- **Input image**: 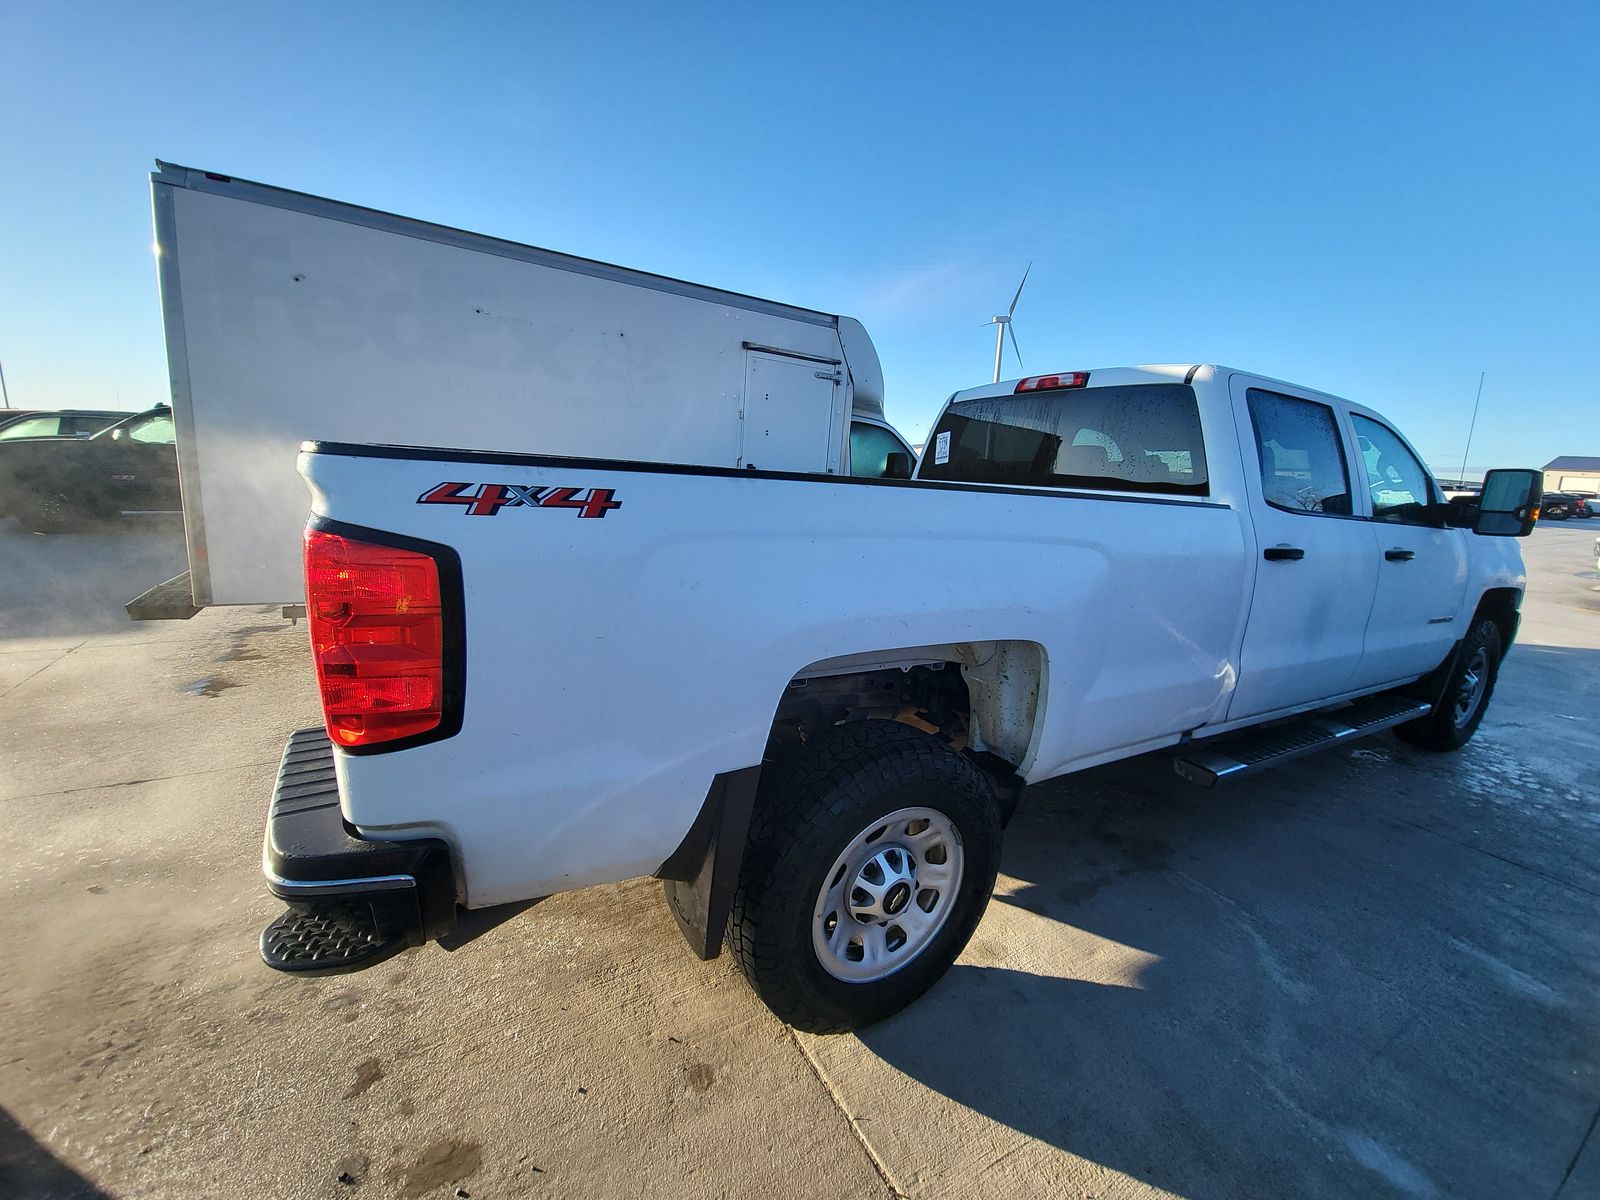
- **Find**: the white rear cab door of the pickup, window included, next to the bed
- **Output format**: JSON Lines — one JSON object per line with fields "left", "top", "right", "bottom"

{"left": 1227, "top": 385, "right": 1378, "bottom": 722}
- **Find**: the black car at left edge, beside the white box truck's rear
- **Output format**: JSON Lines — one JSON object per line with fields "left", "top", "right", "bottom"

{"left": 0, "top": 405, "right": 181, "bottom": 533}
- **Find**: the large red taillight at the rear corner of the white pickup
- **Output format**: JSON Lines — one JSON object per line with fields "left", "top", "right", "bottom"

{"left": 306, "top": 530, "right": 445, "bottom": 746}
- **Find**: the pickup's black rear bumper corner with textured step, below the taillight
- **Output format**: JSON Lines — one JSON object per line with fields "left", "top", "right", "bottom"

{"left": 261, "top": 730, "right": 456, "bottom": 974}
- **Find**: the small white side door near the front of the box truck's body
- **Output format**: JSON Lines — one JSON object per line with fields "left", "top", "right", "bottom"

{"left": 739, "top": 350, "right": 843, "bottom": 474}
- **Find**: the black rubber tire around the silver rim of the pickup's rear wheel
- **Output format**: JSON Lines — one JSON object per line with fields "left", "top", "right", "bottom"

{"left": 728, "top": 720, "right": 1000, "bottom": 1034}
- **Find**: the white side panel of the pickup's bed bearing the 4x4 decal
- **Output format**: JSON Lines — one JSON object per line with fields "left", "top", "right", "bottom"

{"left": 299, "top": 442, "right": 1253, "bottom": 907}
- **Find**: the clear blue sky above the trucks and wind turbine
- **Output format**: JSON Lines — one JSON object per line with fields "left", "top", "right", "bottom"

{"left": 0, "top": 0, "right": 1600, "bottom": 474}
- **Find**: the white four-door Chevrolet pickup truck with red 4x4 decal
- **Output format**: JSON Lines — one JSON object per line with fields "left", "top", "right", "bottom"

{"left": 262, "top": 365, "right": 1539, "bottom": 1030}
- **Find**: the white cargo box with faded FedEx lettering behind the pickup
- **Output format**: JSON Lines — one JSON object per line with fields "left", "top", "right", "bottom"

{"left": 151, "top": 162, "right": 909, "bottom": 614}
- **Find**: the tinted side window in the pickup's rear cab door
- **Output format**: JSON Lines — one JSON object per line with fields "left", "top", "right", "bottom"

{"left": 1246, "top": 387, "right": 1352, "bottom": 517}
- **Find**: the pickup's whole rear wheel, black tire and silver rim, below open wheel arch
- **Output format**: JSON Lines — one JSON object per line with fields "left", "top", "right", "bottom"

{"left": 728, "top": 722, "right": 1000, "bottom": 1034}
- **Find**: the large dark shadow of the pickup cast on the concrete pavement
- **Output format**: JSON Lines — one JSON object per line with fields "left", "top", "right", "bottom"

{"left": 861, "top": 729, "right": 1600, "bottom": 1198}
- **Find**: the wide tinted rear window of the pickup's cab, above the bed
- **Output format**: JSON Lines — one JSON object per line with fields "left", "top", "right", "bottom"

{"left": 918, "top": 384, "right": 1210, "bottom": 496}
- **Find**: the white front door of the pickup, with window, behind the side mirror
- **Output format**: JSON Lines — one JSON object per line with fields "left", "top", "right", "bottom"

{"left": 1350, "top": 413, "right": 1469, "bottom": 688}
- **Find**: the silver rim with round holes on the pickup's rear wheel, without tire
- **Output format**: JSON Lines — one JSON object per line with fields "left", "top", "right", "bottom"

{"left": 811, "top": 808, "right": 965, "bottom": 984}
